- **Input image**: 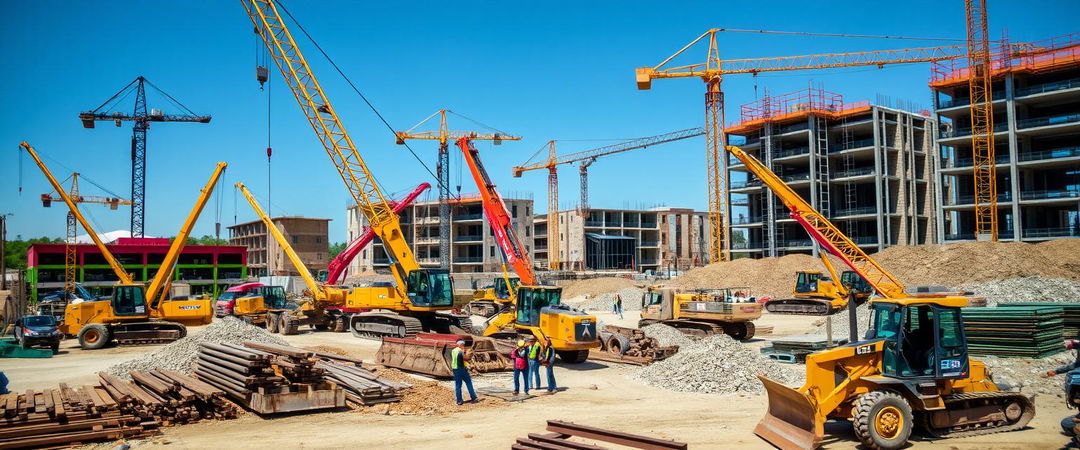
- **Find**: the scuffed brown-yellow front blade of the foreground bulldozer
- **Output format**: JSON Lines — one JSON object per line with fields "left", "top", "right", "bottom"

{"left": 754, "top": 376, "right": 824, "bottom": 450}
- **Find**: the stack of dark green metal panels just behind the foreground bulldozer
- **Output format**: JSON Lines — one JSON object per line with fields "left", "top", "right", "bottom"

{"left": 962, "top": 304, "right": 1065, "bottom": 358}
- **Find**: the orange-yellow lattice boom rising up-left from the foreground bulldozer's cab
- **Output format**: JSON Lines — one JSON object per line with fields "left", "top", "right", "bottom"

{"left": 727, "top": 146, "right": 904, "bottom": 298}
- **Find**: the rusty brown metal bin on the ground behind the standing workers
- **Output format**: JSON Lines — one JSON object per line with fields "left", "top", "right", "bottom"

{"left": 375, "top": 332, "right": 510, "bottom": 378}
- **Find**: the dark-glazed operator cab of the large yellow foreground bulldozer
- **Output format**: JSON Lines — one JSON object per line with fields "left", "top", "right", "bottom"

{"left": 866, "top": 302, "right": 969, "bottom": 380}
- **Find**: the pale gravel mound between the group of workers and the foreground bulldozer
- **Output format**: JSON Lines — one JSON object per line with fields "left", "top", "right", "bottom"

{"left": 630, "top": 335, "right": 801, "bottom": 394}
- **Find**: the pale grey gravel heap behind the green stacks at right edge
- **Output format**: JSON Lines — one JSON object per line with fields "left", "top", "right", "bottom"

{"left": 960, "top": 276, "right": 1080, "bottom": 306}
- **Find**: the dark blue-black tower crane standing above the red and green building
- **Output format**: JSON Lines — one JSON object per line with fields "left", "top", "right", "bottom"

{"left": 79, "top": 76, "right": 211, "bottom": 237}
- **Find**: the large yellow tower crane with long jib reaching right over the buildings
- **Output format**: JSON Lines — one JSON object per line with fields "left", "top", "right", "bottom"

{"left": 635, "top": 32, "right": 993, "bottom": 262}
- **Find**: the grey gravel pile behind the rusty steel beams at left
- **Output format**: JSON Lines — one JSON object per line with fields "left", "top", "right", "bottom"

{"left": 105, "top": 317, "right": 288, "bottom": 380}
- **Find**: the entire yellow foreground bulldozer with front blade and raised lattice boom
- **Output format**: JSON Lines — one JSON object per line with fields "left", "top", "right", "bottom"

{"left": 726, "top": 146, "right": 1035, "bottom": 449}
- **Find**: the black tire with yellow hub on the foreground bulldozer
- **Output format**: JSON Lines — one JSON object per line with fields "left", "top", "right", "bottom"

{"left": 851, "top": 391, "right": 913, "bottom": 450}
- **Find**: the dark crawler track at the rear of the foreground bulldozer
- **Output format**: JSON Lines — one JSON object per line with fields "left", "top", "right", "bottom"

{"left": 921, "top": 392, "right": 1035, "bottom": 438}
